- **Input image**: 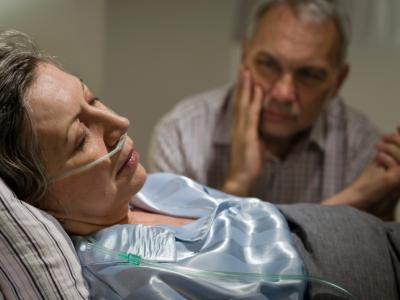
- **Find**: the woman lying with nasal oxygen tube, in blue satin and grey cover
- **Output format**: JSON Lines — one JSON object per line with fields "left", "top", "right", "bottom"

{"left": 0, "top": 31, "right": 400, "bottom": 299}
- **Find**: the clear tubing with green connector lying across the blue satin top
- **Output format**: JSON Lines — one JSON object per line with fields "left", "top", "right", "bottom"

{"left": 79, "top": 237, "right": 358, "bottom": 300}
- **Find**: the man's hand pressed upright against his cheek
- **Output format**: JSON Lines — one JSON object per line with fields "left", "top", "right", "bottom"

{"left": 222, "top": 69, "right": 265, "bottom": 196}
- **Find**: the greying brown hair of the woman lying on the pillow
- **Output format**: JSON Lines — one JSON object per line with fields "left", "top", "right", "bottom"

{"left": 0, "top": 30, "right": 53, "bottom": 204}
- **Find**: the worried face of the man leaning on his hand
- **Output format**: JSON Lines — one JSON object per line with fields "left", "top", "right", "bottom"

{"left": 242, "top": 6, "right": 347, "bottom": 140}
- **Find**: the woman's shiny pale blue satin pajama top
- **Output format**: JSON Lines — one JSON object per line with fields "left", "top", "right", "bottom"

{"left": 74, "top": 173, "right": 306, "bottom": 299}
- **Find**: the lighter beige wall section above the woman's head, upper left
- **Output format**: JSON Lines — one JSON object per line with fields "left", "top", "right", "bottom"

{"left": 0, "top": 0, "right": 106, "bottom": 92}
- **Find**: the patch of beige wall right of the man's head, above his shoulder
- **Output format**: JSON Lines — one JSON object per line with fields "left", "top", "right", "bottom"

{"left": 343, "top": 44, "right": 400, "bottom": 131}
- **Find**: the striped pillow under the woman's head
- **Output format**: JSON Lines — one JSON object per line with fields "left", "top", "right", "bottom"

{"left": 0, "top": 179, "right": 89, "bottom": 300}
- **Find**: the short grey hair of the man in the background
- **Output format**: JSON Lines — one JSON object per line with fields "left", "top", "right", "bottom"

{"left": 247, "top": 0, "right": 351, "bottom": 63}
